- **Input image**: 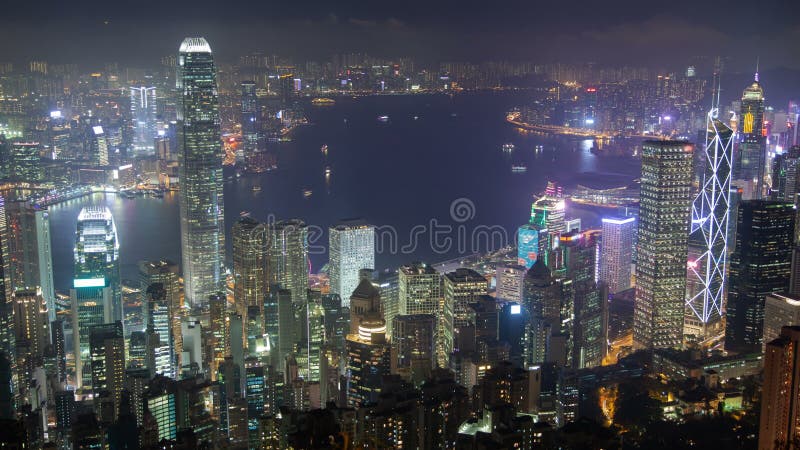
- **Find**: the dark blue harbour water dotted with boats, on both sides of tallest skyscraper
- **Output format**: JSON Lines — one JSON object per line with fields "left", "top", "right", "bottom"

{"left": 51, "top": 93, "right": 640, "bottom": 290}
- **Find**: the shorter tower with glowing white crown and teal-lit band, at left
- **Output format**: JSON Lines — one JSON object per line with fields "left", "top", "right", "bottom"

{"left": 70, "top": 206, "right": 122, "bottom": 386}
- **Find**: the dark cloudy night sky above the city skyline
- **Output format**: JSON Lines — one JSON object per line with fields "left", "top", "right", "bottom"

{"left": 0, "top": 0, "right": 800, "bottom": 70}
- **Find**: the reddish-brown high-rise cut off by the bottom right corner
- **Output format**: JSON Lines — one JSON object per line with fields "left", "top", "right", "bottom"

{"left": 758, "top": 326, "right": 800, "bottom": 450}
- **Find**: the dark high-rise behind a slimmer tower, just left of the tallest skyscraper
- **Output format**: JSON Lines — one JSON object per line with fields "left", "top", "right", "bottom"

{"left": 139, "top": 260, "right": 184, "bottom": 372}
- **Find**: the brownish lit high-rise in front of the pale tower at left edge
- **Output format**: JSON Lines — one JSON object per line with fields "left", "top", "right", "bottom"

{"left": 12, "top": 288, "right": 50, "bottom": 387}
